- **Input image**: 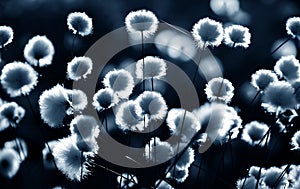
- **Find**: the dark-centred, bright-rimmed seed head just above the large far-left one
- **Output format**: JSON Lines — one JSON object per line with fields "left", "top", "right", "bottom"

{"left": 24, "top": 35, "right": 55, "bottom": 67}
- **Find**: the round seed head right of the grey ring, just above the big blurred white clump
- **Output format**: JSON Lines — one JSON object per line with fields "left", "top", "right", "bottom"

{"left": 205, "top": 77, "right": 234, "bottom": 103}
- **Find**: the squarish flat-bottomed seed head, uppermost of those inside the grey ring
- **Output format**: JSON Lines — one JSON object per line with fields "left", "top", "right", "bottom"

{"left": 135, "top": 56, "right": 167, "bottom": 79}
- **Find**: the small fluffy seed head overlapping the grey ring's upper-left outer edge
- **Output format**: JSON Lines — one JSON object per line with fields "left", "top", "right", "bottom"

{"left": 67, "top": 56, "right": 93, "bottom": 81}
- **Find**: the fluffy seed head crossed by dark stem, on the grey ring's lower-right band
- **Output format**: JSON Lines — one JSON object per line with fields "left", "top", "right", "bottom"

{"left": 166, "top": 108, "right": 201, "bottom": 142}
